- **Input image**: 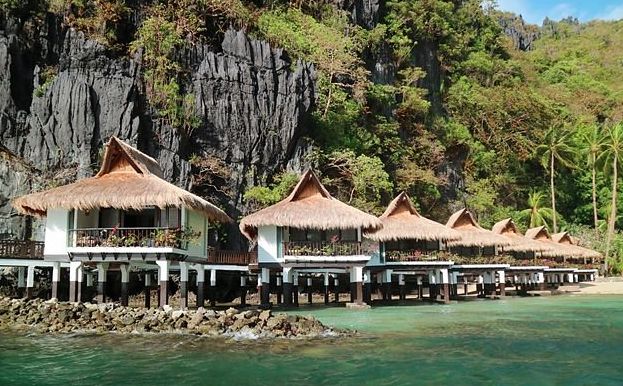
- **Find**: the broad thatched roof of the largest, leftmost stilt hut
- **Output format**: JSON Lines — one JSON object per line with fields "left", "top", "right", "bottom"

{"left": 12, "top": 136, "right": 232, "bottom": 222}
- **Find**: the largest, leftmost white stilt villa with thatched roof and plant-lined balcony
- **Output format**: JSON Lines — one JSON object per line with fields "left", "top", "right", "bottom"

{"left": 12, "top": 137, "right": 234, "bottom": 307}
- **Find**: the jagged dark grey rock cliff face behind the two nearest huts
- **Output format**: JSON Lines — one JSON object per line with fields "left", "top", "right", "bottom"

{"left": 0, "top": 15, "right": 315, "bottom": 246}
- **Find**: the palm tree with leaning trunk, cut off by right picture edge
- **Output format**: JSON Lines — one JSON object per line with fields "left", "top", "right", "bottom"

{"left": 597, "top": 122, "right": 623, "bottom": 272}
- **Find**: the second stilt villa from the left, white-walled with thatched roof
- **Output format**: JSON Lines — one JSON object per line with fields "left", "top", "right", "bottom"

{"left": 240, "top": 170, "right": 383, "bottom": 303}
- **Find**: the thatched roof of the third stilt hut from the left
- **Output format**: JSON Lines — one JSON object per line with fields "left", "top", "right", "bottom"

{"left": 366, "top": 192, "right": 461, "bottom": 241}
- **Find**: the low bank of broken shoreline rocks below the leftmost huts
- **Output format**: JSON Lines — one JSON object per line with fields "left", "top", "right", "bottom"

{"left": 0, "top": 297, "right": 350, "bottom": 339}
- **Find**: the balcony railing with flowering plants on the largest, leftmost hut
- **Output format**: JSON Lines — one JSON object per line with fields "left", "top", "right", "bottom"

{"left": 68, "top": 228, "right": 189, "bottom": 249}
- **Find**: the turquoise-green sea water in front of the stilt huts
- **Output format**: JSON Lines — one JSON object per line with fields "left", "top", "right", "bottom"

{"left": 0, "top": 296, "right": 623, "bottom": 385}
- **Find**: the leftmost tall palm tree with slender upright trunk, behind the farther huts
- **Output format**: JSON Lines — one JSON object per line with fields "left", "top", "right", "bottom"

{"left": 536, "top": 127, "right": 575, "bottom": 233}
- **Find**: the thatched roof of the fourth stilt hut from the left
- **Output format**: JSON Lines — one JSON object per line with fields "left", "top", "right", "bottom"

{"left": 446, "top": 208, "right": 511, "bottom": 248}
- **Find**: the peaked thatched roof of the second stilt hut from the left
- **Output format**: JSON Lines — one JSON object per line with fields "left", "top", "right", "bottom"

{"left": 240, "top": 170, "right": 383, "bottom": 240}
